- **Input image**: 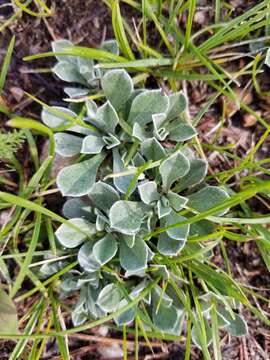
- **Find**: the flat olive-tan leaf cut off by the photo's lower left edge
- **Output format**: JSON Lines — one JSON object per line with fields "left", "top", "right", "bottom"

{"left": 0, "top": 289, "right": 19, "bottom": 336}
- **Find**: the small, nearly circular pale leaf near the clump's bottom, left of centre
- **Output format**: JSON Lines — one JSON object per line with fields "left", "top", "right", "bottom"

{"left": 97, "top": 284, "right": 123, "bottom": 312}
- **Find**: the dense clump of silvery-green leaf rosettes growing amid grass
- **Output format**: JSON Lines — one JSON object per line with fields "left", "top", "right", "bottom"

{"left": 39, "top": 39, "right": 246, "bottom": 346}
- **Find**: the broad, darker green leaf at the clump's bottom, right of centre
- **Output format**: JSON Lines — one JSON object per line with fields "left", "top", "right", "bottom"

{"left": 152, "top": 301, "right": 180, "bottom": 335}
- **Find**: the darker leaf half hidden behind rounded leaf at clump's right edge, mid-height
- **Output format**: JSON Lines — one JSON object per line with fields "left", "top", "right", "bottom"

{"left": 179, "top": 159, "right": 208, "bottom": 190}
